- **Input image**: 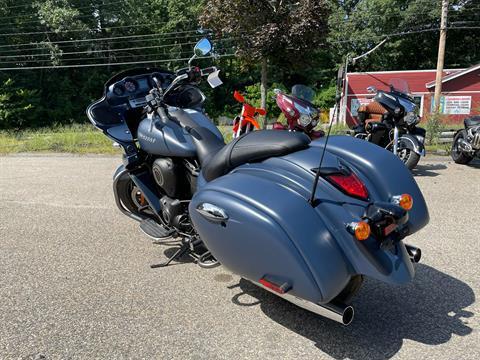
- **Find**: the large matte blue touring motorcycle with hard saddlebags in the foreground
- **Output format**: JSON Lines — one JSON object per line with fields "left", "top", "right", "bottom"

{"left": 87, "top": 39, "right": 428, "bottom": 324}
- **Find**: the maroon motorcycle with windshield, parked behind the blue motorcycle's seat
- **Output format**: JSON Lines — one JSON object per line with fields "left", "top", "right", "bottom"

{"left": 273, "top": 85, "right": 325, "bottom": 140}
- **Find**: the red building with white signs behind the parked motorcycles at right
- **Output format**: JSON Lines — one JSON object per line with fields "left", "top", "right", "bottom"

{"left": 343, "top": 64, "right": 480, "bottom": 125}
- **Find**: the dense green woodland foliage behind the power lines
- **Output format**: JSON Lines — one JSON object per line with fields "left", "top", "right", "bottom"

{"left": 0, "top": 0, "right": 480, "bottom": 129}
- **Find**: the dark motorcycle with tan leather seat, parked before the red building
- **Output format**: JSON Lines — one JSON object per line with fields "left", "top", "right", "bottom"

{"left": 354, "top": 79, "right": 426, "bottom": 170}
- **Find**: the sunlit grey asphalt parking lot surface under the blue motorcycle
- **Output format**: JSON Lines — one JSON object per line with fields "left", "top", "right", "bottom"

{"left": 0, "top": 155, "right": 480, "bottom": 359}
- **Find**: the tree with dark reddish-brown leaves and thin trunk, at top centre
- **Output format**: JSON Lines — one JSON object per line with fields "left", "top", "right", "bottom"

{"left": 200, "top": 0, "right": 330, "bottom": 126}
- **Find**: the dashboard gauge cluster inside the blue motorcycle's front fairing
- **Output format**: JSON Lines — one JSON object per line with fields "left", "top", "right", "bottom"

{"left": 107, "top": 73, "right": 172, "bottom": 108}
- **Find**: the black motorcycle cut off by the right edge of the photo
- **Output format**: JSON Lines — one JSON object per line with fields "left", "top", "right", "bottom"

{"left": 451, "top": 116, "right": 480, "bottom": 164}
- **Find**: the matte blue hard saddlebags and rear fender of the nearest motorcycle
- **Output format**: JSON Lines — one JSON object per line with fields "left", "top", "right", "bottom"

{"left": 189, "top": 136, "right": 428, "bottom": 303}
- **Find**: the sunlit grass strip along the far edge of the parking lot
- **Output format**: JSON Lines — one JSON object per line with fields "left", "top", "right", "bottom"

{"left": 0, "top": 124, "right": 455, "bottom": 154}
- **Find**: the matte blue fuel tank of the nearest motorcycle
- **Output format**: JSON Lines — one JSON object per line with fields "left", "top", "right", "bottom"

{"left": 137, "top": 107, "right": 223, "bottom": 157}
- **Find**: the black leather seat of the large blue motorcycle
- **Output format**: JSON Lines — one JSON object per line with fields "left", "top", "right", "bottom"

{"left": 191, "top": 128, "right": 310, "bottom": 181}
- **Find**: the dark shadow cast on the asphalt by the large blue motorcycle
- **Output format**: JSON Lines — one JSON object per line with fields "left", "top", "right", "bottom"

{"left": 232, "top": 264, "right": 475, "bottom": 359}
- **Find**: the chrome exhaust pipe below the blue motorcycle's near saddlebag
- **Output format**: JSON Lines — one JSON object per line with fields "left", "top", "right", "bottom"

{"left": 250, "top": 280, "right": 355, "bottom": 326}
